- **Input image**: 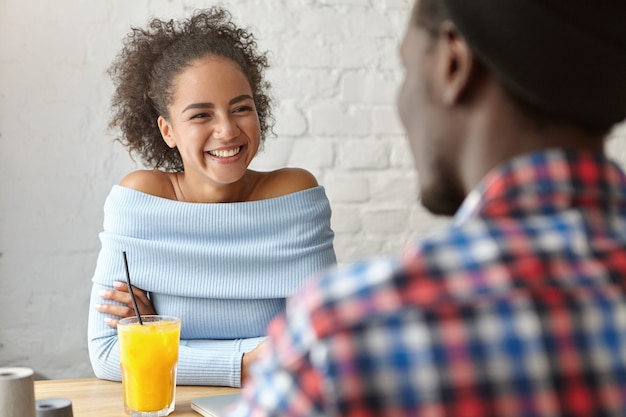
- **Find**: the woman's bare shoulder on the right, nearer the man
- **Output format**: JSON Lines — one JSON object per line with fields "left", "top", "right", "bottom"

{"left": 249, "top": 168, "right": 318, "bottom": 199}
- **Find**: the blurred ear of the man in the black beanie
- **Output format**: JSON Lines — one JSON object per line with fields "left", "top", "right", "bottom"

{"left": 438, "top": 21, "right": 478, "bottom": 106}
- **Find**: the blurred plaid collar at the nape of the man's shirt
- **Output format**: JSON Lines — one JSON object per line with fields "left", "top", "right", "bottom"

{"left": 453, "top": 149, "right": 626, "bottom": 225}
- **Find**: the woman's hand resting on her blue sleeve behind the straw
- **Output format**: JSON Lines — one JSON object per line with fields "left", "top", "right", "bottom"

{"left": 96, "top": 281, "right": 157, "bottom": 328}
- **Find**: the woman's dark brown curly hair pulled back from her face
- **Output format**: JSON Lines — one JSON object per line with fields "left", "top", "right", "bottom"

{"left": 109, "top": 7, "right": 274, "bottom": 172}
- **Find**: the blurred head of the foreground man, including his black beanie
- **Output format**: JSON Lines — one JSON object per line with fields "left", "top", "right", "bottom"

{"left": 398, "top": 0, "right": 626, "bottom": 214}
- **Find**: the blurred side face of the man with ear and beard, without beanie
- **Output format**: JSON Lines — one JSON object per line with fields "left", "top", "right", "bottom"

{"left": 398, "top": 0, "right": 472, "bottom": 215}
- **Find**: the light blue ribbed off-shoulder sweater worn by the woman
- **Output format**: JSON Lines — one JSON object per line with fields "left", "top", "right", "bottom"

{"left": 88, "top": 185, "right": 336, "bottom": 387}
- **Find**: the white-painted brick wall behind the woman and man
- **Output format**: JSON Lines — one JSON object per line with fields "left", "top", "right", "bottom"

{"left": 0, "top": 0, "right": 626, "bottom": 378}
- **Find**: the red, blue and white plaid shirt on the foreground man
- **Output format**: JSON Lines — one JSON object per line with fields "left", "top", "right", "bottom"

{"left": 227, "top": 150, "right": 626, "bottom": 417}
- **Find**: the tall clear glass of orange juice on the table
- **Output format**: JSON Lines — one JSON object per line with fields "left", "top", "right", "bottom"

{"left": 117, "top": 315, "right": 180, "bottom": 417}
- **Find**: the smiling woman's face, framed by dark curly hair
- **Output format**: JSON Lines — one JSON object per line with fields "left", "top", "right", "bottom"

{"left": 158, "top": 56, "right": 261, "bottom": 185}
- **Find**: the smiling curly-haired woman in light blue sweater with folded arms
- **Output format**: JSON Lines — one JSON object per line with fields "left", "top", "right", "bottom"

{"left": 88, "top": 8, "right": 335, "bottom": 386}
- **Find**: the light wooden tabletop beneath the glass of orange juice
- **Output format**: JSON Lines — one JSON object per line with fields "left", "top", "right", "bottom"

{"left": 34, "top": 378, "right": 239, "bottom": 417}
